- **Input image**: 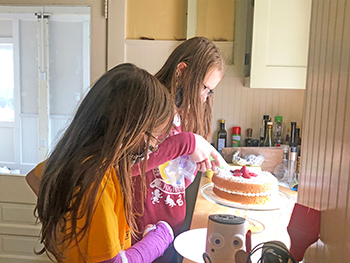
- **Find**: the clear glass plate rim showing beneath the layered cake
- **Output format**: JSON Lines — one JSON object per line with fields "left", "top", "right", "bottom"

{"left": 201, "top": 183, "right": 289, "bottom": 211}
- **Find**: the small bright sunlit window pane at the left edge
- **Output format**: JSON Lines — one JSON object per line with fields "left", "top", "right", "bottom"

{"left": 0, "top": 43, "right": 15, "bottom": 122}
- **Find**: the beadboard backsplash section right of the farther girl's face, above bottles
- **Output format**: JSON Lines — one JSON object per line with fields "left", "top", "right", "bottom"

{"left": 212, "top": 76, "right": 304, "bottom": 146}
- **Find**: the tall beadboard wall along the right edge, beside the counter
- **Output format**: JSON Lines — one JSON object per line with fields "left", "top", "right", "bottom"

{"left": 298, "top": 0, "right": 350, "bottom": 262}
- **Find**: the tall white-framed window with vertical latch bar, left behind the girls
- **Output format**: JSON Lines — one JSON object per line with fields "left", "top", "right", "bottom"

{"left": 0, "top": 5, "right": 90, "bottom": 174}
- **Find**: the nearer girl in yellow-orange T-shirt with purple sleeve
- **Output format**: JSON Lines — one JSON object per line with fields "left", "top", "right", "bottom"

{"left": 36, "top": 64, "right": 179, "bottom": 262}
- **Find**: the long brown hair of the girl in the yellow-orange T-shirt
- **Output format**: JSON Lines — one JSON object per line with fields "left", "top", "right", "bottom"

{"left": 37, "top": 64, "right": 174, "bottom": 261}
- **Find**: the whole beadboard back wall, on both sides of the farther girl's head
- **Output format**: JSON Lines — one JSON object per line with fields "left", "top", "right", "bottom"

{"left": 125, "top": 39, "right": 304, "bottom": 146}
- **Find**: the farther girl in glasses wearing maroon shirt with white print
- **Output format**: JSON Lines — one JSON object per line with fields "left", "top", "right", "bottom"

{"left": 132, "top": 37, "right": 225, "bottom": 262}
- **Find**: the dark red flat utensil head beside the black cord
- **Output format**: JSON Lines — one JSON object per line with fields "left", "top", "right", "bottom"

{"left": 287, "top": 203, "right": 321, "bottom": 261}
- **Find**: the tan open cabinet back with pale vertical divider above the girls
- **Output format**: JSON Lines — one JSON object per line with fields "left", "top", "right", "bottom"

{"left": 126, "top": 0, "right": 235, "bottom": 42}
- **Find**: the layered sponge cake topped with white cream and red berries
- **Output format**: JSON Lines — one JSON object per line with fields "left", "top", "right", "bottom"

{"left": 212, "top": 166, "right": 278, "bottom": 205}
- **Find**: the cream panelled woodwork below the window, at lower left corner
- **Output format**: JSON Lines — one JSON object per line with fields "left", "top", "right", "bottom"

{"left": 0, "top": 175, "right": 51, "bottom": 263}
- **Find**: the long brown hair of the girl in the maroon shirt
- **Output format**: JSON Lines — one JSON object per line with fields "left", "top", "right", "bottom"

{"left": 155, "top": 37, "right": 225, "bottom": 140}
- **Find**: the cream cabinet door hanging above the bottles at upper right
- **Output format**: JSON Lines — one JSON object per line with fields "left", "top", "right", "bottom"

{"left": 250, "top": 0, "right": 311, "bottom": 89}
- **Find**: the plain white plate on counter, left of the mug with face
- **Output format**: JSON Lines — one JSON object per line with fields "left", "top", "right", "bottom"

{"left": 174, "top": 228, "right": 207, "bottom": 263}
